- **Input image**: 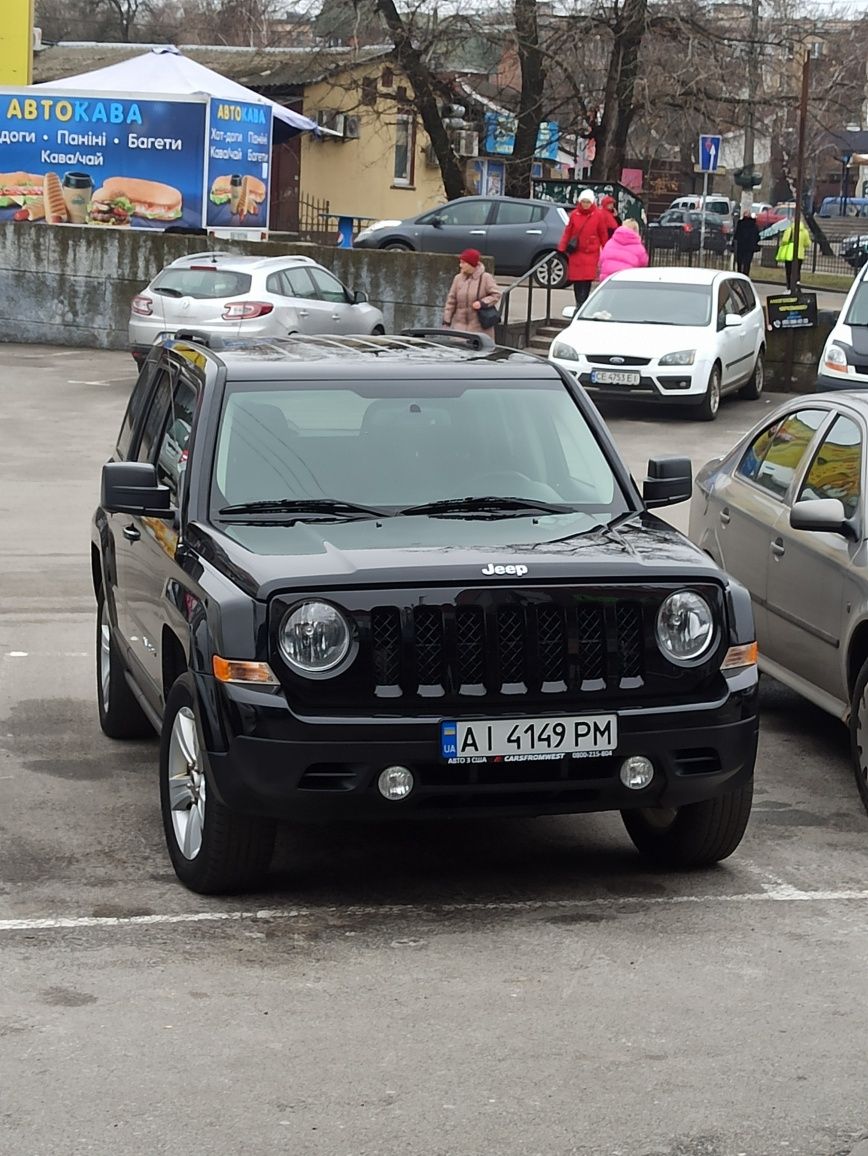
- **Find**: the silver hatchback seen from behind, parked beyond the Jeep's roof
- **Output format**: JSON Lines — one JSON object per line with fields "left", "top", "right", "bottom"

{"left": 129, "top": 252, "right": 386, "bottom": 361}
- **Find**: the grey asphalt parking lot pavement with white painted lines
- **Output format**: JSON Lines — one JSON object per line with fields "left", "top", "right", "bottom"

{"left": 0, "top": 346, "right": 868, "bottom": 1156}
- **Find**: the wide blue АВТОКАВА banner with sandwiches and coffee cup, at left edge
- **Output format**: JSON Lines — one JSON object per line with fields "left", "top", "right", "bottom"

{"left": 0, "top": 88, "right": 207, "bottom": 229}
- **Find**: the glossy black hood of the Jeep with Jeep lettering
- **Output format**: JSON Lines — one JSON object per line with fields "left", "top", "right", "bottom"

{"left": 186, "top": 513, "right": 720, "bottom": 600}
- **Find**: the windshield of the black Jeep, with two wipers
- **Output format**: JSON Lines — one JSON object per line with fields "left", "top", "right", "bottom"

{"left": 212, "top": 381, "right": 630, "bottom": 523}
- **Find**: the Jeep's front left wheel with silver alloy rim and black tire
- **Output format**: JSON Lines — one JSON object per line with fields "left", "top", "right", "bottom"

{"left": 159, "top": 673, "right": 276, "bottom": 895}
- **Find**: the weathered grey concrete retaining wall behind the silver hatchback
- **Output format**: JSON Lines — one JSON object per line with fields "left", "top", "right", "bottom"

{"left": 0, "top": 223, "right": 455, "bottom": 349}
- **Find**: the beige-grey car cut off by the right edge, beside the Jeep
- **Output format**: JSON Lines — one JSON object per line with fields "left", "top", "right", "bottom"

{"left": 690, "top": 392, "right": 868, "bottom": 809}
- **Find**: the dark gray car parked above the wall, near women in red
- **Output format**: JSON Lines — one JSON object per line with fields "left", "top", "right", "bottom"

{"left": 353, "top": 197, "right": 567, "bottom": 289}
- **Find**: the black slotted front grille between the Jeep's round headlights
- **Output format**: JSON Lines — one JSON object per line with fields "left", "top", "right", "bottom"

{"left": 371, "top": 601, "right": 645, "bottom": 696}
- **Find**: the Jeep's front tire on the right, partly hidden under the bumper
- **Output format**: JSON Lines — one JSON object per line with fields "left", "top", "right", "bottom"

{"left": 621, "top": 775, "right": 754, "bottom": 867}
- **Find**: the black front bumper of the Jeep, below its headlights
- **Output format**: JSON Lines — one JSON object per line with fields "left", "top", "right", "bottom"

{"left": 196, "top": 668, "right": 758, "bottom": 821}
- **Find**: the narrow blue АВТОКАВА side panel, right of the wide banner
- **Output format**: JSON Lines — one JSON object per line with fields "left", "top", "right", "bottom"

{"left": 206, "top": 99, "right": 272, "bottom": 231}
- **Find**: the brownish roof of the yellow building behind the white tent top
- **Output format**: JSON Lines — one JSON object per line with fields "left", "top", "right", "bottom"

{"left": 34, "top": 42, "right": 394, "bottom": 92}
